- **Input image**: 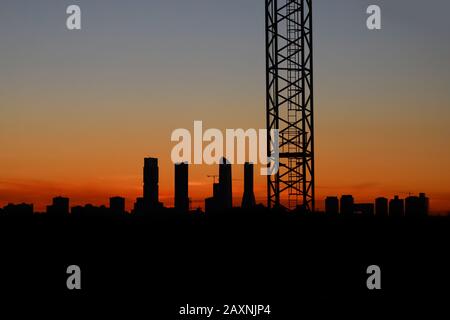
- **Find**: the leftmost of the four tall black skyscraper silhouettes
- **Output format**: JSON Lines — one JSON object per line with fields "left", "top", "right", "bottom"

{"left": 144, "top": 158, "right": 160, "bottom": 209}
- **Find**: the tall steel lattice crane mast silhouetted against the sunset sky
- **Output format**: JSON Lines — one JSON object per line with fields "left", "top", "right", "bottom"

{"left": 265, "top": 0, "right": 314, "bottom": 211}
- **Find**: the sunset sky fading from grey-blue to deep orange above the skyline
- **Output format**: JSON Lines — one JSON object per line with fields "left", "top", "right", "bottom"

{"left": 0, "top": 0, "right": 450, "bottom": 212}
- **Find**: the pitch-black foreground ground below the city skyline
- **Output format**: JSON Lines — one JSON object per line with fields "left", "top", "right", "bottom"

{"left": 0, "top": 212, "right": 450, "bottom": 319}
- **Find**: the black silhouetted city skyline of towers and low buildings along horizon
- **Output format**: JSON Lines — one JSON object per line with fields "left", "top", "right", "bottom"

{"left": 0, "top": 158, "right": 440, "bottom": 218}
